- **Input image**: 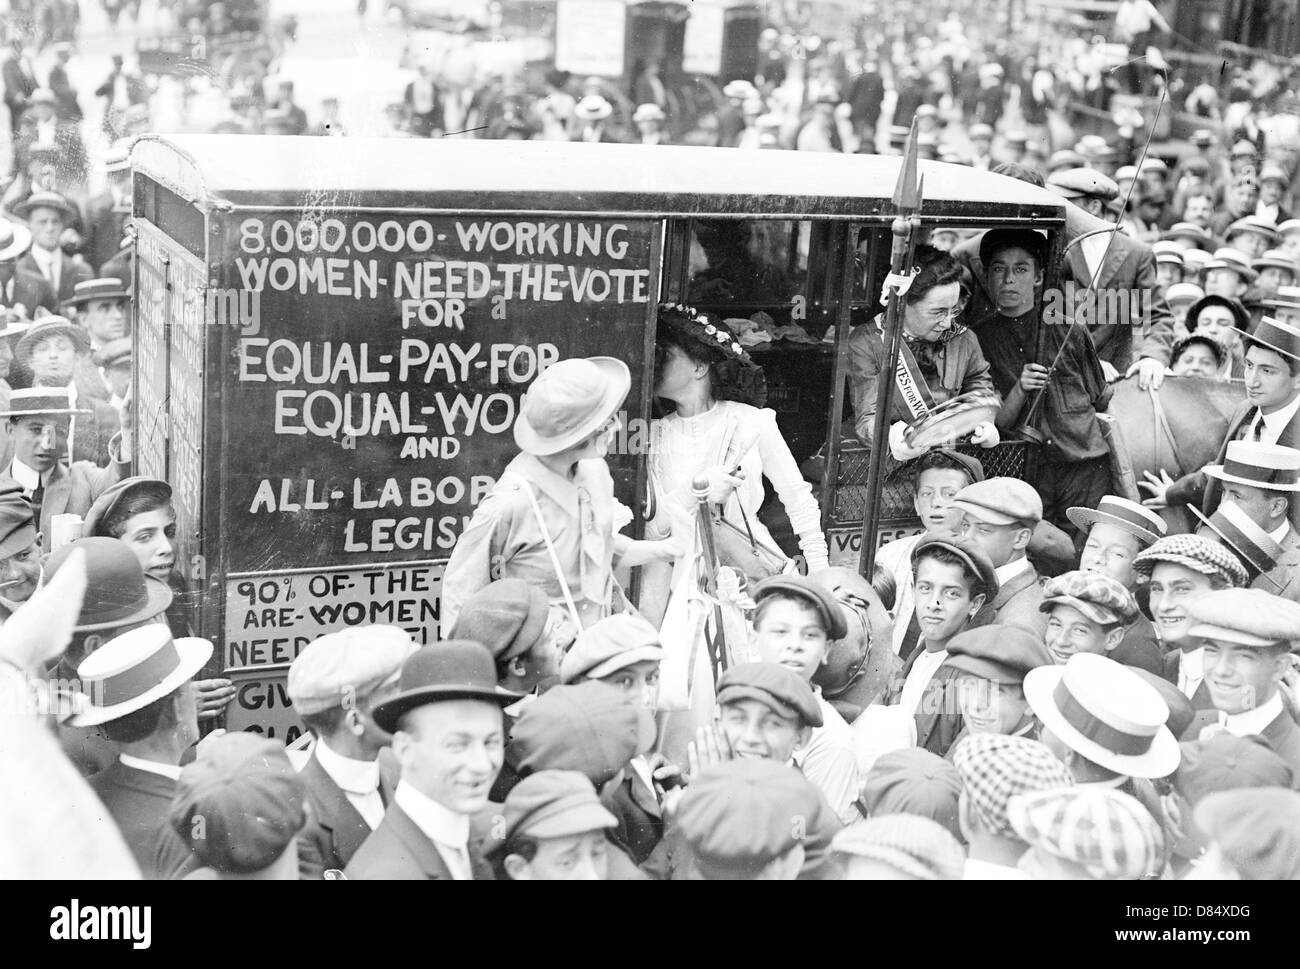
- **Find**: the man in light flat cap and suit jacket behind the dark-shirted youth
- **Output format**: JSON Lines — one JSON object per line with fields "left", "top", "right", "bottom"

{"left": 1047, "top": 168, "right": 1174, "bottom": 380}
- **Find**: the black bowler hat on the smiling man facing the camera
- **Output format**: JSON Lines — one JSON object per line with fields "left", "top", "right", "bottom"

{"left": 372, "top": 640, "right": 519, "bottom": 734}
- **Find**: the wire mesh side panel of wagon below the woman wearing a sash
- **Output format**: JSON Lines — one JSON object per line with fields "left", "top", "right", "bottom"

{"left": 831, "top": 441, "right": 1030, "bottom": 527}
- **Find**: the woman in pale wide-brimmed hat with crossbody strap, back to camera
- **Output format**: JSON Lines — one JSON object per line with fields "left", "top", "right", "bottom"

{"left": 442, "top": 356, "right": 676, "bottom": 632}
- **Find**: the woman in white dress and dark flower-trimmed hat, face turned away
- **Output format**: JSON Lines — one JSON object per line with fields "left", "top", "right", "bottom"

{"left": 641, "top": 303, "right": 829, "bottom": 622}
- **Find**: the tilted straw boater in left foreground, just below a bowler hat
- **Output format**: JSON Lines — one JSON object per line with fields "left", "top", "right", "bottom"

{"left": 69, "top": 623, "right": 212, "bottom": 727}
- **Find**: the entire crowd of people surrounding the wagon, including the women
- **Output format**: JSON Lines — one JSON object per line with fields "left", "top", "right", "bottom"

{"left": 0, "top": 1, "right": 1300, "bottom": 881}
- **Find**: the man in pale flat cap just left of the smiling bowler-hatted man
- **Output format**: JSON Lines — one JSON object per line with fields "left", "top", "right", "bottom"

{"left": 287, "top": 626, "right": 416, "bottom": 879}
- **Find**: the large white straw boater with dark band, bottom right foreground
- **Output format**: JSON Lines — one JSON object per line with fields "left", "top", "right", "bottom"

{"left": 1024, "top": 653, "right": 1180, "bottom": 778}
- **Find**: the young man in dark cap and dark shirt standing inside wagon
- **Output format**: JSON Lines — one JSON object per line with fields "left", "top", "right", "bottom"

{"left": 976, "top": 229, "right": 1118, "bottom": 533}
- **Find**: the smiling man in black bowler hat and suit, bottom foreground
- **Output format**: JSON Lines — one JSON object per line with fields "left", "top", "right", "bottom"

{"left": 346, "top": 640, "right": 519, "bottom": 881}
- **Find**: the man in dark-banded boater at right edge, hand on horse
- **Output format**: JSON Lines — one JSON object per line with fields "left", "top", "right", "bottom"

{"left": 1140, "top": 316, "right": 1300, "bottom": 527}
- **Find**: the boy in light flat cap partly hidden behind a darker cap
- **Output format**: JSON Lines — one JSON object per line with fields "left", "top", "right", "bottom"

{"left": 560, "top": 613, "right": 676, "bottom": 865}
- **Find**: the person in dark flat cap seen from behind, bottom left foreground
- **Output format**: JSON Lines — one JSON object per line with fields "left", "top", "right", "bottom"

{"left": 168, "top": 731, "right": 307, "bottom": 882}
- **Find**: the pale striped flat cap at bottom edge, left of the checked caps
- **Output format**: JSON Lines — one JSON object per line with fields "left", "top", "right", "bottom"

{"left": 831, "top": 814, "right": 966, "bottom": 882}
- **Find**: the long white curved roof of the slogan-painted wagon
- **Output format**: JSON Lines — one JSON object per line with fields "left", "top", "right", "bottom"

{"left": 131, "top": 135, "right": 1065, "bottom": 221}
